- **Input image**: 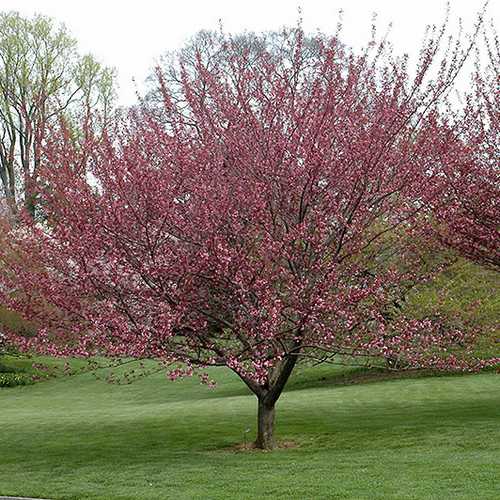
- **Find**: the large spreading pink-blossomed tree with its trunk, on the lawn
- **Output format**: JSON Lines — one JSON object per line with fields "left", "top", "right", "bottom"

{"left": 0, "top": 19, "right": 496, "bottom": 448}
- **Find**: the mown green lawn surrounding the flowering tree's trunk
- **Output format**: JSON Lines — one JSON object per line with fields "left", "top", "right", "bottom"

{"left": 0, "top": 360, "right": 500, "bottom": 500}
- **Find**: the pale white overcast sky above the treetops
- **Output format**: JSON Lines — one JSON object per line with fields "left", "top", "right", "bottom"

{"left": 0, "top": 0, "right": 500, "bottom": 105}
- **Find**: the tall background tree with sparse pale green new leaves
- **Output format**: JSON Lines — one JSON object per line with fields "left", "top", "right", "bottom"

{"left": 0, "top": 12, "right": 114, "bottom": 219}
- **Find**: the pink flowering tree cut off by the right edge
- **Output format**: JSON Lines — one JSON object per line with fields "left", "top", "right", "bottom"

{"left": 436, "top": 26, "right": 500, "bottom": 270}
